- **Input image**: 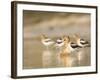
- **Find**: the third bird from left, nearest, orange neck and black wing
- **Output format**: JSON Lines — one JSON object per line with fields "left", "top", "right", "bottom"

{"left": 64, "top": 36, "right": 80, "bottom": 53}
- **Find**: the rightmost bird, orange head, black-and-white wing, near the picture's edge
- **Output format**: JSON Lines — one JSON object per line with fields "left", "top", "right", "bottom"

{"left": 74, "top": 34, "right": 90, "bottom": 48}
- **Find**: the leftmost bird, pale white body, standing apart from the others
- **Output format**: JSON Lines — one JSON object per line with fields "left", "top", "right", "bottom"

{"left": 41, "top": 34, "right": 55, "bottom": 49}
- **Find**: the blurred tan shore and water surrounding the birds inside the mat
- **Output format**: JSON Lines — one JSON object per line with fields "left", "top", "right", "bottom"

{"left": 23, "top": 10, "right": 91, "bottom": 69}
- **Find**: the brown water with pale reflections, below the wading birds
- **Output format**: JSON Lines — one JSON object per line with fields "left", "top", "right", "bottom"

{"left": 23, "top": 39, "right": 91, "bottom": 69}
